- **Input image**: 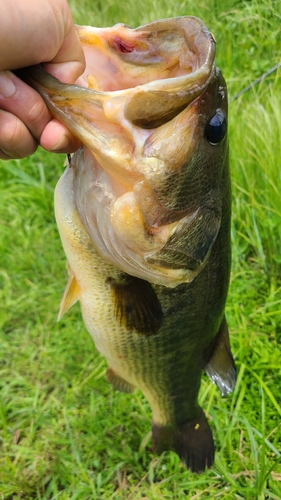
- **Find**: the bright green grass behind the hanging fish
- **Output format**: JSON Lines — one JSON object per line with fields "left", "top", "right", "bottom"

{"left": 0, "top": 0, "right": 281, "bottom": 500}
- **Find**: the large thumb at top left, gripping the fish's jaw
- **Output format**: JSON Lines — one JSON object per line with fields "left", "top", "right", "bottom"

{"left": 0, "top": 0, "right": 83, "bottom": 75}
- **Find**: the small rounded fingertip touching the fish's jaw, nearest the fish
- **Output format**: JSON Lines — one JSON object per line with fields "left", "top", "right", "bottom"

{"left": 40, "top": 120, "right": 81, "bottom": 153}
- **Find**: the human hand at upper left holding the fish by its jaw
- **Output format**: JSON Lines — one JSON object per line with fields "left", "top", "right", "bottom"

{"left": 0, "top": 0, "right": 85, "bottom": 159}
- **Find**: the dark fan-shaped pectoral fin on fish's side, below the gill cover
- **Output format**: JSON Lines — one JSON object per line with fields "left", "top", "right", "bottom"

{"left": 107, "top": 274, "right": 163, "bottom": 335}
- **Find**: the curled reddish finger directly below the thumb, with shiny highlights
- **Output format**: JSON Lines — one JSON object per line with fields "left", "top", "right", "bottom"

{"left": 0, "top": 71, "right": 51, "bottom": 140}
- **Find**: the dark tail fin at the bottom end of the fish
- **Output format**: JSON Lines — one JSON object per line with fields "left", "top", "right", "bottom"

{"left": 152, "top": 410, "right": 215, "bottom": 473}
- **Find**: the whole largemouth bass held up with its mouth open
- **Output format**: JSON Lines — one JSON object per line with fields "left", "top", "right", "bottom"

{"left": 19, "top": 16, "right": 236, "bottom": 473}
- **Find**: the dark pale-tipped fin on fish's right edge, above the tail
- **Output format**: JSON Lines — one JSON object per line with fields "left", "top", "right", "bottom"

{"left": 205, "top": 317, "right": 236, "bottom": 396}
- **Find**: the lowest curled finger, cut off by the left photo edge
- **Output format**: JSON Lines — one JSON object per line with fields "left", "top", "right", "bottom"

{"left": 0, "top": 109, "right": 38, "bottom": 159}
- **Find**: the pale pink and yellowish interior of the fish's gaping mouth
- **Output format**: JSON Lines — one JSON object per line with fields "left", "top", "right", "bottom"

{"left": 77, "top": 17, "right": 214, "bottom": 92}
